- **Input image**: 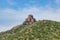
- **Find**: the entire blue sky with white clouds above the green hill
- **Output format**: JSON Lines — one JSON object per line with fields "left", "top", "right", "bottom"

{"left": 0, "top": 0, "right": 60, "bottom": 32}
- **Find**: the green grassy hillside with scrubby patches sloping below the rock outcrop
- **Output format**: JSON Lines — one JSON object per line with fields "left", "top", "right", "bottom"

{"left": 0, "top": 20, "right": 60, "bottom": 40}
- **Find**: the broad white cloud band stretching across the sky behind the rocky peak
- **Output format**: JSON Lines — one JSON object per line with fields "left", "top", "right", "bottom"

{"left": 1, "top": 7, "right": 60, "bottom": 21}
